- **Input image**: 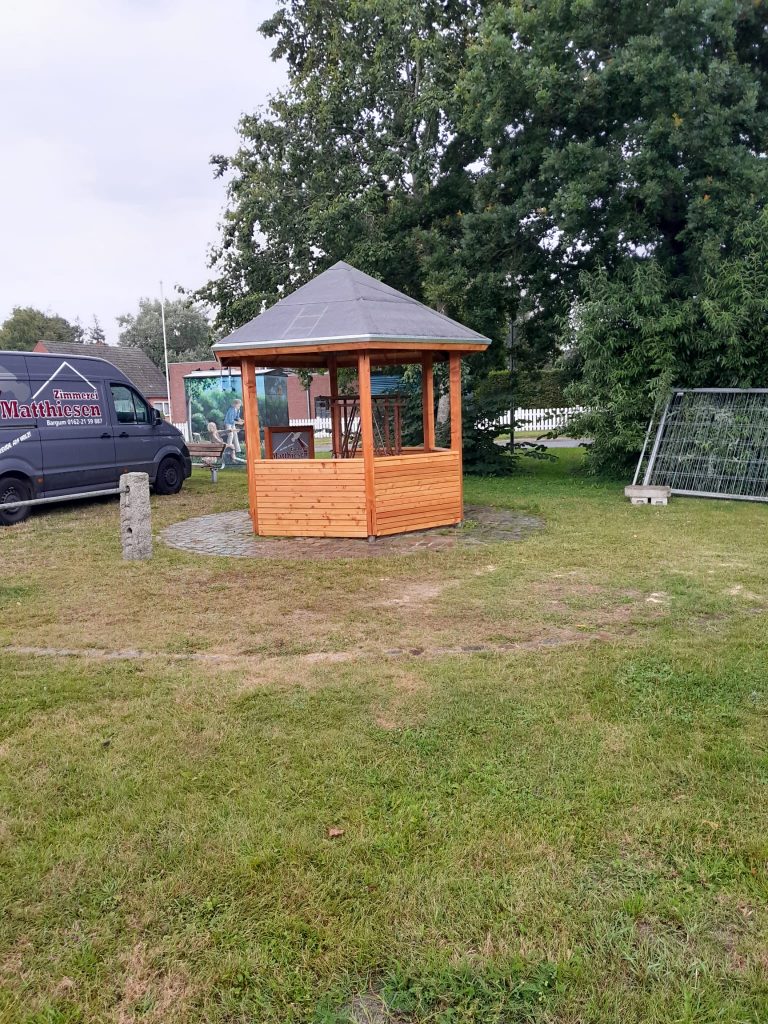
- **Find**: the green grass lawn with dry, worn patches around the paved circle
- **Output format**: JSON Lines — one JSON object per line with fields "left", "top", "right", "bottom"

{"left": 0, "top": 458, "right": 768, "bottom": 1024}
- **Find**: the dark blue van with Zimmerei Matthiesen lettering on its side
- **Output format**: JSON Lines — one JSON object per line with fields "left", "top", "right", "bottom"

{"left": 0, "top": 352, "right": 191, "bottom": 525}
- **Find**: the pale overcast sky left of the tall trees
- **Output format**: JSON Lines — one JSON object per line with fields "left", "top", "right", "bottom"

{"left": 0, "top": 0, "right": 283, "bottom": 342}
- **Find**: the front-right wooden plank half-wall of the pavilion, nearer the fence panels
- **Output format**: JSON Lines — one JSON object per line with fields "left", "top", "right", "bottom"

{"left": 374, "top": 451, "right": 463, "bottom": 536}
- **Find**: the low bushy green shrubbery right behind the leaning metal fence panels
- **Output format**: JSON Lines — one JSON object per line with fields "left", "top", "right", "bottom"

{"left": 571, "top": 210, "right": 768, "bottom": 470}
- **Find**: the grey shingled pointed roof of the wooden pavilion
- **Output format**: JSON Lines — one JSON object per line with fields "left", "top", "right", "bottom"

{"left": 213, "top": 262, "right": 489, "bottom": 352}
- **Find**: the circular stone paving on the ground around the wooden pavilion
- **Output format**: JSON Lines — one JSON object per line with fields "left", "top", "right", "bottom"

{"left": 160, "top": 505, "right": 544, "bottom": 559}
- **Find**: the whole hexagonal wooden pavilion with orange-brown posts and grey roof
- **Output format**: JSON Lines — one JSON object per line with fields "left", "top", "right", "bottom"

{"left": 213, "top": 262, "right": 489, "bottom": 540}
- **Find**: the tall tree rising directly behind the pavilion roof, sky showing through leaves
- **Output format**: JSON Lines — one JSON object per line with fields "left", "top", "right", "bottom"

{"left": 202, "top": 0, "right": 488, "bottom": 339}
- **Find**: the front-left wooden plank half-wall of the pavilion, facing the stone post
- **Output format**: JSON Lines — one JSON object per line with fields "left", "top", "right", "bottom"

{"left": 254, "top": 459, "right": 368, "bottom": 537}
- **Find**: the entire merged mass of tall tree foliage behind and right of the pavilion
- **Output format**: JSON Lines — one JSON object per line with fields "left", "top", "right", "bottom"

{"left": 200, "top": 0, "right": 768, "bottom": 466}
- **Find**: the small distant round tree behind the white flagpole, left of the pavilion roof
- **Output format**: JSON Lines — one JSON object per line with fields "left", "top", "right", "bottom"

{"left": 117, "top": 299, "right": 212, "bottom": 367}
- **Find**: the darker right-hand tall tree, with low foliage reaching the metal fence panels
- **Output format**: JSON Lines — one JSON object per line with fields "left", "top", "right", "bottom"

{"left": 460, "top": 0, "right": 768, "bottom": 468}
